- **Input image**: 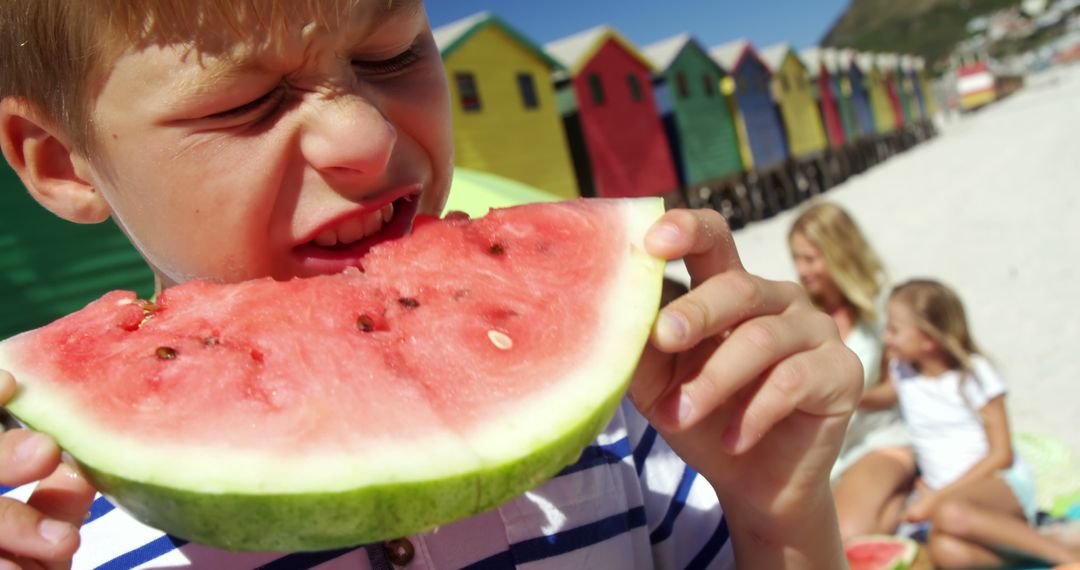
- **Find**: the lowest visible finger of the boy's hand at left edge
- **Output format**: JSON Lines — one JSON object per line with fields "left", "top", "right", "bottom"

{"left": 0, "top": 499, "right": 79, "bottom": 561}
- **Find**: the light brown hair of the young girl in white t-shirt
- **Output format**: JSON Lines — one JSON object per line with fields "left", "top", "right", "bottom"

{"left": 889, "top": 280, "right": 983, "bottom": 377}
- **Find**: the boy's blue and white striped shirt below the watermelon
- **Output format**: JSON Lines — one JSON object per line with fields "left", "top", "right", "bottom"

{"left": 0, "top": 401, "right": 734, "bottom": 570}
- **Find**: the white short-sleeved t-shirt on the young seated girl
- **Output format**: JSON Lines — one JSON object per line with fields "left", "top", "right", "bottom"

{"left": 889, "top": 355, "right": 1005, "bottom": 489}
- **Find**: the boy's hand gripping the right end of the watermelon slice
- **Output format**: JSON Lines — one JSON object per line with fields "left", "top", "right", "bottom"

{"left": 630, "top": 209, "right": 862, "bottom": 540}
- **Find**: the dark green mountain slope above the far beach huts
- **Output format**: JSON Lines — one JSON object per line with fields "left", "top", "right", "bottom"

{"left": 821, "top": 0, "right": 1020, "bottom": 66}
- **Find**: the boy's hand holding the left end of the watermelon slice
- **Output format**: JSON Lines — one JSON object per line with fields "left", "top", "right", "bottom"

{"left": 0, "top": 370, "right": 95, "bottom": 569}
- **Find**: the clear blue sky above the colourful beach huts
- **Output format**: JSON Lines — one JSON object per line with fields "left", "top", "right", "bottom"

{"left": 426, "top": 0, "right": 849, "bottom": 49}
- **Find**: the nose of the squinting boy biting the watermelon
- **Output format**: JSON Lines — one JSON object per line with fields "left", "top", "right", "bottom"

{"left": 300, "top": 94, "right": 397, "bottom": 176}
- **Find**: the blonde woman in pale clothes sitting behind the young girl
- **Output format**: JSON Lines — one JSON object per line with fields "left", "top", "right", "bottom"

{"left": 787, "top": 202, "right": 915, "bottom": 540}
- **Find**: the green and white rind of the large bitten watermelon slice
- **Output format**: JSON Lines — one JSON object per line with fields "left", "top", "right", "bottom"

{"left": 0, "top": 200, "right": 664, "bottom": 551}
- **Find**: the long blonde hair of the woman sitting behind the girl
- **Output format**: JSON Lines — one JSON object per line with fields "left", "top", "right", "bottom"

{"left": 787, "top": 202, "right": 888, "bottom": 323}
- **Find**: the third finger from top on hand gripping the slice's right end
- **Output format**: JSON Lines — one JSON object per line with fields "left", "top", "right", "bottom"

{"left": 648, "top": 311, "right": 835, "bottom": 429}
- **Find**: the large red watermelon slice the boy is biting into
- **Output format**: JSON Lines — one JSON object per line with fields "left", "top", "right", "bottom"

{"left": 0, "top": 199, "right": 663, "bottom": 551}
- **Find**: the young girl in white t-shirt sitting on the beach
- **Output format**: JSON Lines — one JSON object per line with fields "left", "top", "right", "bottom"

{"left": 885, "top": 281, "right": 1080, "bottom": 568}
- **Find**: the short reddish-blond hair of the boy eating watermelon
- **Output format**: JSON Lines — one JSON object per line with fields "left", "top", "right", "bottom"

{"left": 0, "top": 0, "right": 397, "bottom": 153}
